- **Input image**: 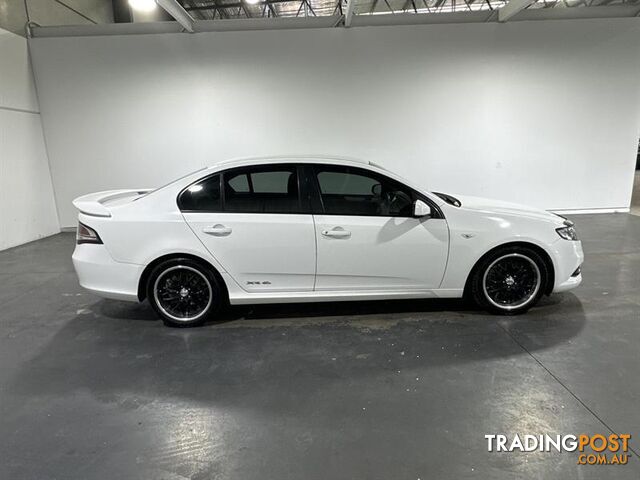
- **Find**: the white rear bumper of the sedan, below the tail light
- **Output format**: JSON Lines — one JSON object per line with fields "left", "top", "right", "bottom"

{"left": 71, "top": 244, "right": 144, "bottom": 302}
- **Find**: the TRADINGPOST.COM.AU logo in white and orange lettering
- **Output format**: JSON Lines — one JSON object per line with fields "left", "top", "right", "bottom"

{"left": 484, "top": 433, "right": 631, "bottom": 465}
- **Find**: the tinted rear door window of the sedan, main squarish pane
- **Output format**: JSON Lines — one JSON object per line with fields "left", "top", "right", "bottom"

{"left": 223, "top": 165, "right": 300, "bottom": 213}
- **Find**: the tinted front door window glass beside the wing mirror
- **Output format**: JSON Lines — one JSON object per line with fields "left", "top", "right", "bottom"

{"left": 315, "top": 165, "right": 413, "bottom": 217}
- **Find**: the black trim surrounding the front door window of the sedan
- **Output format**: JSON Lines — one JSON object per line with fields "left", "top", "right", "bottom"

{"left": 306, "top": 163, "right": 444, "bottom": 219}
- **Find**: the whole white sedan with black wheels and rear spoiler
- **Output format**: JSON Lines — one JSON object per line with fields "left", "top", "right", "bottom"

{"left": 73, "top": 157, "right": 584, "bottom": 326}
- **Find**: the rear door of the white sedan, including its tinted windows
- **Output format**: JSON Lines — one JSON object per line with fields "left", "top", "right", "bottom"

{"left": 179, "top": 164, "right": 316, "bottom": 292}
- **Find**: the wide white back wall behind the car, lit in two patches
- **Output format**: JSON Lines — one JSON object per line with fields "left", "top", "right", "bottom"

{"left": 31, "top": 19, "right": 640, "bottom": 226}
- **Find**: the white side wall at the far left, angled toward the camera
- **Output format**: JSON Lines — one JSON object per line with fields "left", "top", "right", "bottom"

{"left": 0, "top": 29, "right": 60, "bottom": 250}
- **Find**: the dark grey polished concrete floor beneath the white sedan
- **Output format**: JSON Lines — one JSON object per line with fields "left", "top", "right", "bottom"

{"left": 0, "top": 214, "right": 640, "bottom": 480}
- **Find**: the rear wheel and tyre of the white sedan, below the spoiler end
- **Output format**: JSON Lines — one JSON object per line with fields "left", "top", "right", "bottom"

{"left": 147, "top": 258, "right": 224, "bottom": 327}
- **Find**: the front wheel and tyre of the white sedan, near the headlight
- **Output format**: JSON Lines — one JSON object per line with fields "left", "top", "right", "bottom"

{"left": 471, "top": 246, "right": 549, "bottom": 315}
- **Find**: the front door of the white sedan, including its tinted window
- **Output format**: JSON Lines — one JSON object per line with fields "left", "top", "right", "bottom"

{"left": 310, "top": 165, "right": 449, "bottom": 291}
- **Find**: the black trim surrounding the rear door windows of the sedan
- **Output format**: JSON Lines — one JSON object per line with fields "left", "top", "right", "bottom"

{"left": 176, "top": 163, "right": 312, "bottom": 215}
